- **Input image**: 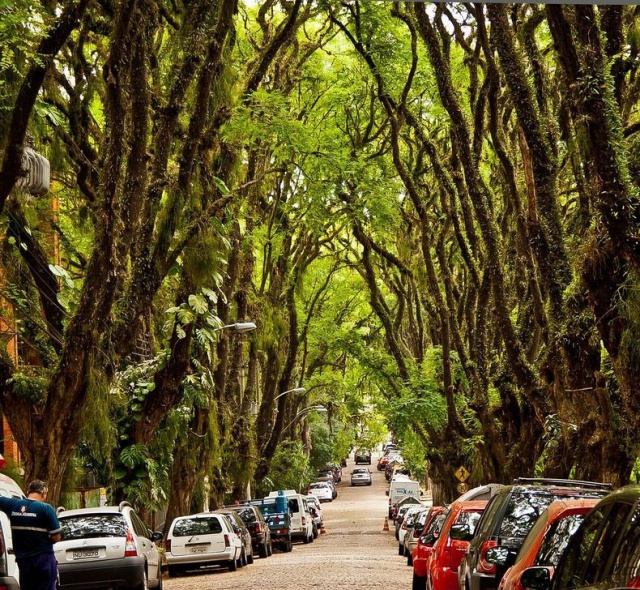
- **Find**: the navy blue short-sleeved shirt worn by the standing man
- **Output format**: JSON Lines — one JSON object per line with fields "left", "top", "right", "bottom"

{"left": 0, "top": 497, "right": 62, "bottom": 559}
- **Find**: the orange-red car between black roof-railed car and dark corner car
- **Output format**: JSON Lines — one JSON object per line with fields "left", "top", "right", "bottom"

{"left": 496, "top": 499, "right": 598, "bottom": 590}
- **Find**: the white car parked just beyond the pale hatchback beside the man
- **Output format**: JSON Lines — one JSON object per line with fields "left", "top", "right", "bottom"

{"left": 165, "top": 512, "right": 243, "bottom": 577}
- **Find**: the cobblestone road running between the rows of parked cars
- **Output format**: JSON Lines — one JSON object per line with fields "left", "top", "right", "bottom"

{"left": 164, "top": 455, "right": 413, "bottom": 590}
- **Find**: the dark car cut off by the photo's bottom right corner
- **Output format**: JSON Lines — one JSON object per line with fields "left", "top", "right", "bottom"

{"left": 520, "top": 484, "right": 640, "bottom": 590}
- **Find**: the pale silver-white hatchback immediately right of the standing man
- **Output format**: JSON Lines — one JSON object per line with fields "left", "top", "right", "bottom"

{"left": 54, "top": 502, "right": 162, "bottom": 590}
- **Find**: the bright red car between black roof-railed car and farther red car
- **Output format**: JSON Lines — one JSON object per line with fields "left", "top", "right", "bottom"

{"left": 427, "top": 500, "right": 487, "bottom": 590}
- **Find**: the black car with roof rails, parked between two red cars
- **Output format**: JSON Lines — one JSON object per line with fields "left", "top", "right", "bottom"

{"left": 458, "top": 478, "right": 611, "bottom": 590}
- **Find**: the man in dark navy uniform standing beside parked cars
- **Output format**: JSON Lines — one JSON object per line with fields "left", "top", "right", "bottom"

{"left": 0, "top": 479, "right": 62, "bottom": 590}
